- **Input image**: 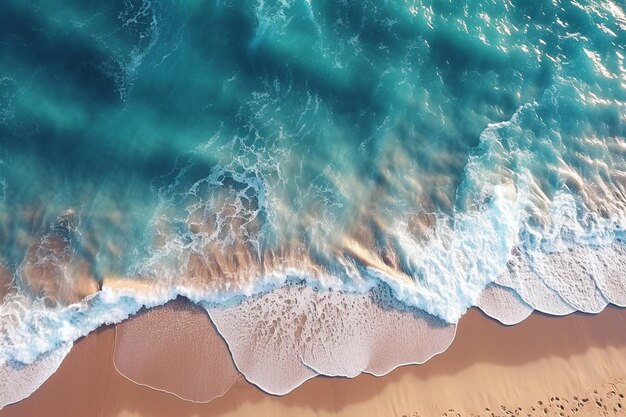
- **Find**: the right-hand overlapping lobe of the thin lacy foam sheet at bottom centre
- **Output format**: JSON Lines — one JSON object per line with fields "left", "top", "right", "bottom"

{"left": 298, "top": 286, "right": 456, "bottom": 377}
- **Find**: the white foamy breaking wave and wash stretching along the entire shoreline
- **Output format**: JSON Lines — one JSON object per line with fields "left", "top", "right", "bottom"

{"left": 0, "top": 88, "right": 625, "bottom": 404}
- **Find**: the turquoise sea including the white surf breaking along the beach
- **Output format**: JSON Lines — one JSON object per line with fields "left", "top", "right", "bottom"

{"left": 0, "top": 0, "right": 626, "bottom": 396}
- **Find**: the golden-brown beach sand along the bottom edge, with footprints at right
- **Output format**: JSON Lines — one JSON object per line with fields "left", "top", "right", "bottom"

{"left": 0, "top": 307, "right": 626, "bottom": 417}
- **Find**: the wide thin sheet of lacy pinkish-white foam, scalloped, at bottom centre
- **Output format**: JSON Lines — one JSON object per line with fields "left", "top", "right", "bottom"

{"left": 207, "top": 286, "right": 456, "bottom": 395}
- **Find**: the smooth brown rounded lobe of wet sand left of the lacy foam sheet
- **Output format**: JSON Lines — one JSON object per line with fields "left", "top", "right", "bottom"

{"left": 113, "top": 298, "right": 242, "bottom": 402}
